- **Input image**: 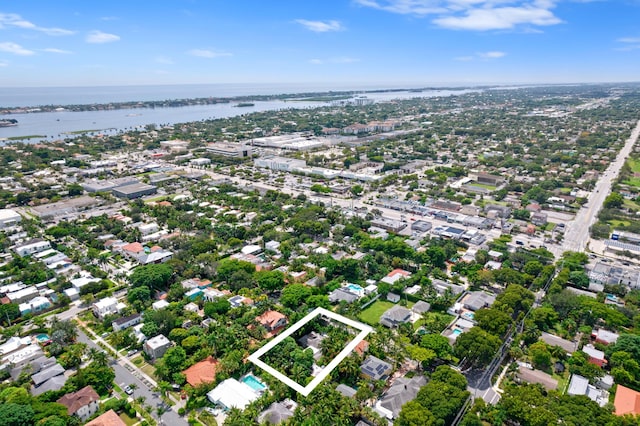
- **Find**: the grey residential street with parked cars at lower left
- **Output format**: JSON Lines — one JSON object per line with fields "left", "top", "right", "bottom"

{"left": 78, "top": 330, "right": 188, "bottom": 426}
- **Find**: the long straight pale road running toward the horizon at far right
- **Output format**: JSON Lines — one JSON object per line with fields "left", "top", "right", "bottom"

{"left": 563, "top": 121, "right": 640, "bottom": 251}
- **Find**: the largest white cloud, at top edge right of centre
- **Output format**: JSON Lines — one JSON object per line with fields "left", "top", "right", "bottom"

{"left": 355, "top": 0, "right": 563, "bottom": 31}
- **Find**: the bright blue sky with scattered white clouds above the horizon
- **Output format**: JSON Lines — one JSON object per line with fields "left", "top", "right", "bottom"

{"left": 0, "top": 0, "right": 640, "bottom": 87}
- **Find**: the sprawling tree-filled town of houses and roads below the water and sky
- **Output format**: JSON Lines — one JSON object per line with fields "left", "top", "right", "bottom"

{"left": 0, "top": 85, "right": 640, "bottom": 426}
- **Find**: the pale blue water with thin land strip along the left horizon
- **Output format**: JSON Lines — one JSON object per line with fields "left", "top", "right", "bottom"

{"left": 0, "top": 84, "right": 475, "bottom": 144}
